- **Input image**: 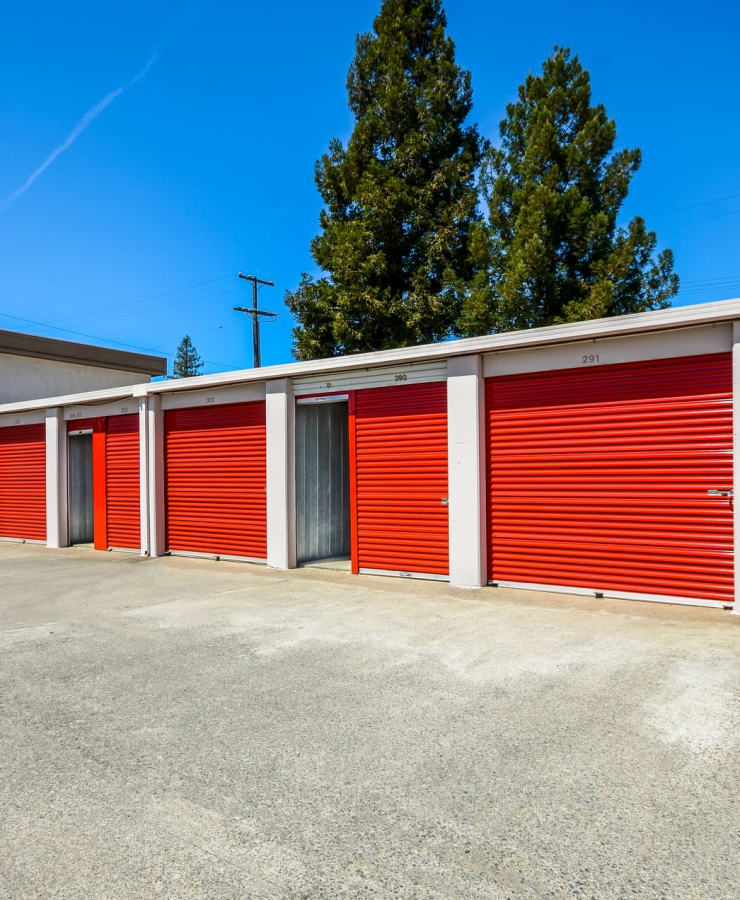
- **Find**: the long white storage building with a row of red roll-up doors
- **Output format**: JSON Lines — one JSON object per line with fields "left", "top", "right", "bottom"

{"left": 0, "top": 300, "right": 740, "bottom": 607}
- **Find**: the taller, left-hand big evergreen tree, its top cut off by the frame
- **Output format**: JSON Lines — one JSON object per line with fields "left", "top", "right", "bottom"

{"left": 286, "top": 0, "right": 482, "bottom": 359}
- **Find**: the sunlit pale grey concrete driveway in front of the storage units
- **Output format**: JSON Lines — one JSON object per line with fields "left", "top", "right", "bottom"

{"left": 0, "top": 544, "right": 740, "bottom": 900}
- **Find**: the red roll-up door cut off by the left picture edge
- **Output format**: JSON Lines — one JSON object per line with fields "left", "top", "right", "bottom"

{"left": 0, "top": 425, "right": 46, "bottom": 541}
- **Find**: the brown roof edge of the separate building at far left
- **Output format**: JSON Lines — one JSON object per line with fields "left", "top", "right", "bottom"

{"left": 0, "top": 329, "right": 167, "bottom": 376}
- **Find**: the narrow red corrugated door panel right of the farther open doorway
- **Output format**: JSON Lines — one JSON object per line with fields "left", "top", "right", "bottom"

{"left": 105, "top": 413, "right": 141, "bottom": 549}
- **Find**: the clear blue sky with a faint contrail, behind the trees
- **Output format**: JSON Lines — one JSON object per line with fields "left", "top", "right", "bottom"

{"left": 0, "top": 0, "right": 740, "bottom": 372}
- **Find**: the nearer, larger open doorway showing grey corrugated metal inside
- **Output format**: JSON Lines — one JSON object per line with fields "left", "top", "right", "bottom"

{"left": 295, "top": 400, "right": 350, "bottom": 563}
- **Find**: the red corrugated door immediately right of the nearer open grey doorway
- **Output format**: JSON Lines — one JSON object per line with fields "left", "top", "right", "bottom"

{"left": 354, "top": 382, "right": 449, "bottom": 575}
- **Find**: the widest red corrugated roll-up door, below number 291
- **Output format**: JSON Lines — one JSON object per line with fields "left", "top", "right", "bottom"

{"left": 486, "top": 353, "right": 733, "bottom": 602}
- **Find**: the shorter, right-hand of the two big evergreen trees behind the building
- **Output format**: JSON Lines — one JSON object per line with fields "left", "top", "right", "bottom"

{"left": 460, "top": 47, "right": 678, "bottom": 335}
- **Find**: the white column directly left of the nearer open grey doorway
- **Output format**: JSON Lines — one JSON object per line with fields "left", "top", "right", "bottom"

{"left": 265, "top": 378, "right": 296, "bottom": 569}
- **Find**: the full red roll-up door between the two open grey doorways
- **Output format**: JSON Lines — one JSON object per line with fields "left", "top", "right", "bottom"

{"left": 164, "top": 401, "right": 267, "bottom": 559}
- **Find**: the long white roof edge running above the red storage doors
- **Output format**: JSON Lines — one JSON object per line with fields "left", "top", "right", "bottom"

{"left": 0, "top": 299, "right": 740, "bottom": 415}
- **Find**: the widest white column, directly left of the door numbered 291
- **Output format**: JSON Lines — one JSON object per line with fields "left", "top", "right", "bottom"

{"left": 447, "top": 356, "right": 488, "bottom": 588}
